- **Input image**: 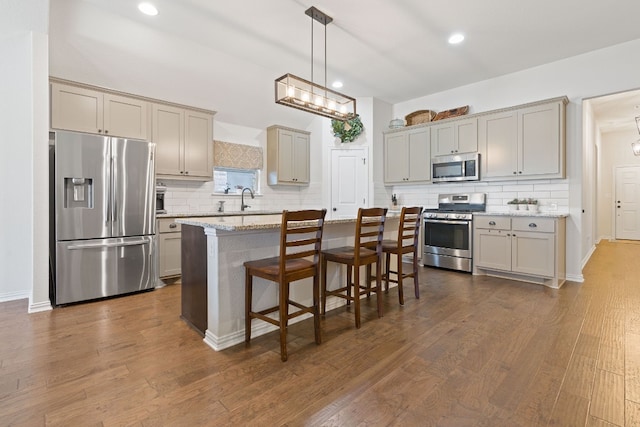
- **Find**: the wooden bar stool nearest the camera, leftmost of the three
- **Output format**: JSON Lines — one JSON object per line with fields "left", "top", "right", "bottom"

{"left": 244, "top": 209, "right": 327, "bottom": 362}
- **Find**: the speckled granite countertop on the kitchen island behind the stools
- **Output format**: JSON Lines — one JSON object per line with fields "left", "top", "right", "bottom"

{"left": 176, "top": 212, "right": 400, "bottom": 231}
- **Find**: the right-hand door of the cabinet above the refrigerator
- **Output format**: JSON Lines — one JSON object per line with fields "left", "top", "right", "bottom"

{"left": 104, "top": 93, "right": 149, "bottom": 140}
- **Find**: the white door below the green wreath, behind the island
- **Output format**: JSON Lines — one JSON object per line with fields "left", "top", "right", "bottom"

{"left": 329, "top": 148, "right": 369, "bottom": 219}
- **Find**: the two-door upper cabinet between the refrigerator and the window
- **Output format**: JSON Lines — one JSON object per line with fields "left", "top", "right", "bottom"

{"left": 152, "top": 104, "right": 213, "bottom": 181}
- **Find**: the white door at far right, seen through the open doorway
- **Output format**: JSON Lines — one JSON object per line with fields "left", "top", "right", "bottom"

{"left": 614, "top": 166, "right": 640, "bottom": 240}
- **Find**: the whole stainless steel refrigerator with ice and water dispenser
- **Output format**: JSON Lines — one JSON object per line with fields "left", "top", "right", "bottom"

{"left": 50, "top": 131, "right": 157, "bottom": 305}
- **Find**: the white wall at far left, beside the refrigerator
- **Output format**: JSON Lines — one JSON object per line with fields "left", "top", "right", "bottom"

{"left": 0, "top": 0, "right": 51, "bottom": 311}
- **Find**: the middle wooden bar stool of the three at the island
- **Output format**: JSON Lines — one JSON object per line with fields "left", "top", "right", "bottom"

{"left": 321, "top": 208, "right": 387, "bottom": 328}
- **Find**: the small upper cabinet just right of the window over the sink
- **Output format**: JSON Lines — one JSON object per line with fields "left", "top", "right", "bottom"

{"left": 267, "top": 126, "right": 310, "bottom": 185}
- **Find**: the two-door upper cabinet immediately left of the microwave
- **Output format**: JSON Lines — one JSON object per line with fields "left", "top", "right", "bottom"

{"left": 384, "top": 127, "right": 431, "bottom": 184}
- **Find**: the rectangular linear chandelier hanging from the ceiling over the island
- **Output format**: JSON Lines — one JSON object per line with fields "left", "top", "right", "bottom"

{"left": 275, "top": 6, "right": 356, "bottom": 121}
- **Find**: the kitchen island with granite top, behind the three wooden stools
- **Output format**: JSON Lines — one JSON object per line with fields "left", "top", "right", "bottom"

{"left": 176, "top": 213, "right": 399, "bottom": 350}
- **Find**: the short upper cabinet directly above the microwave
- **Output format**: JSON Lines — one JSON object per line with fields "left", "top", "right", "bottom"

{"left": 431, "top": 117, "right": 478, "bottom": 156}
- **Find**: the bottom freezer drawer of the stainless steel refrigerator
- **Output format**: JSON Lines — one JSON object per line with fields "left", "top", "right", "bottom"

{"left": 55, "top": 236, "right": 157, "bottom": 305}
